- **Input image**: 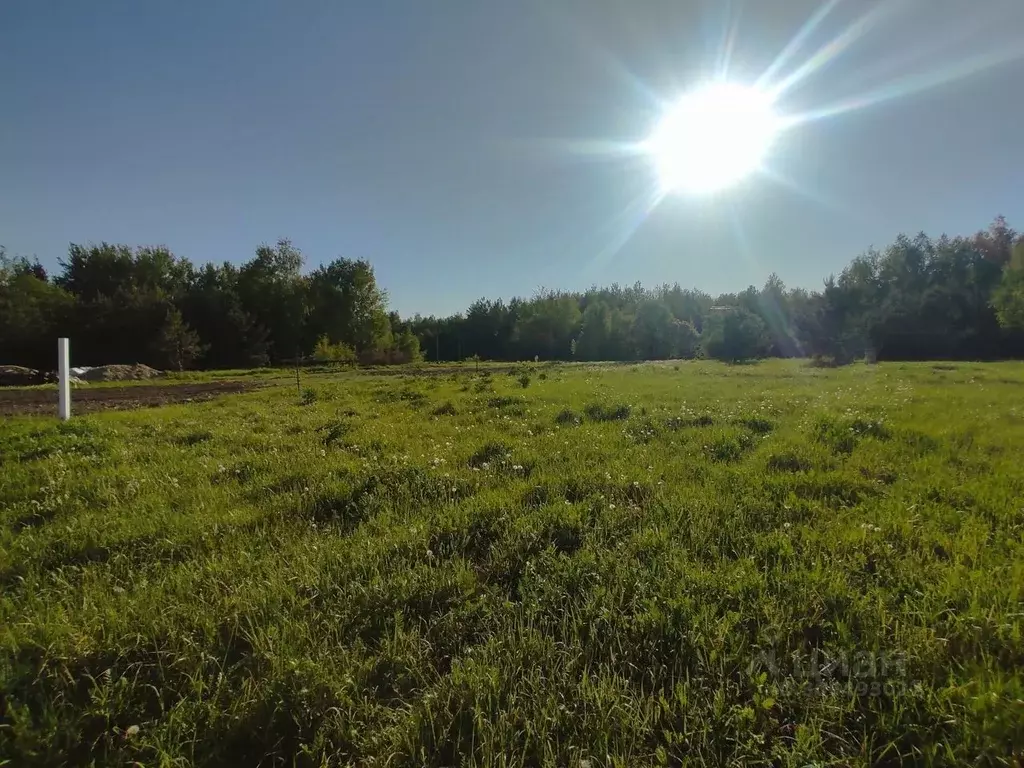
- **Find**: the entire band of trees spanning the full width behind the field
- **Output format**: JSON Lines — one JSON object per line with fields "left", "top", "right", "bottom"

{"left": 0, "top": 217, "right": 1024, "bottom": 369}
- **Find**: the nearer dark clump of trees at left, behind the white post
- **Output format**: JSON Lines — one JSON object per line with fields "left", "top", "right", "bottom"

{"left": 0, "top": 240, "right": 420, "bottom": 369}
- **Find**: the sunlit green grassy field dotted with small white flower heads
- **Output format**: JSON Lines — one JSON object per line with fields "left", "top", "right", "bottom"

{"left": 0, "top": 361, "right": 1024, "bottom": 768}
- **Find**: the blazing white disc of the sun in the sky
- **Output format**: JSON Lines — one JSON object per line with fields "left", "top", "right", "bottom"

{"left": 644, "top": 83, "right": 781, "bottom": 195}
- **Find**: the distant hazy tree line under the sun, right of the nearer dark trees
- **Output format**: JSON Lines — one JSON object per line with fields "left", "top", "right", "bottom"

{"left": 411, "top": 217, "right": 1024, "bottom": 364}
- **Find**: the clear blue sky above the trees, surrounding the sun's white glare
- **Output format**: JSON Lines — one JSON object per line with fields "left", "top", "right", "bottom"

{"left": 0, "top": 0, "right": 1024, "bottom": 314}
